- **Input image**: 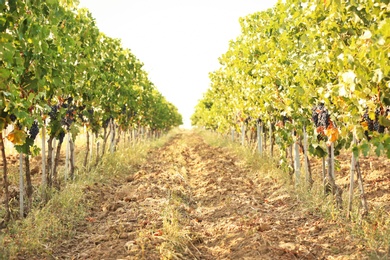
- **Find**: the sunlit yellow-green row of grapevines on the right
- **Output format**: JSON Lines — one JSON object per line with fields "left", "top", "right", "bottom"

{"left": 191, "top": 0, "right": 390, "bottom": 215}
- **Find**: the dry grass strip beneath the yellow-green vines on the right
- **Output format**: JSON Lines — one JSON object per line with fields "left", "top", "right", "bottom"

{"left": 200, "top": 131, "right": 390, "bottom": 259}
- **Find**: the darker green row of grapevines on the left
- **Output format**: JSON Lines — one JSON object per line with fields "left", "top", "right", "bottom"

{"left": 0, "top": 0, "right": 182, "bottom": 223}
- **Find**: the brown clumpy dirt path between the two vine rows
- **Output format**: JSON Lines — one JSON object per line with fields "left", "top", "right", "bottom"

{"left": 48, "top": 133, "right": 362, "bottom": 259}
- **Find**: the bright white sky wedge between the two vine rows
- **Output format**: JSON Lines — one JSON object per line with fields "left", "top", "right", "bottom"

{"left": 80, "top": 0, "right": 276, "bottom": 127}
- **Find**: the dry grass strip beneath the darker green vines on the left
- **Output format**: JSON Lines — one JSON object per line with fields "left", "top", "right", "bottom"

{"left": 0, "top": 130, "right": 174, "bottom": 259}
